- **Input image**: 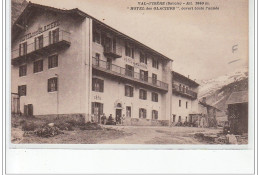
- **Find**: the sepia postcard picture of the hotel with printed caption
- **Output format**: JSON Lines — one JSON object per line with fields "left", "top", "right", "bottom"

{"left": 10, "top": 0, "right": 250, "bottom": 145}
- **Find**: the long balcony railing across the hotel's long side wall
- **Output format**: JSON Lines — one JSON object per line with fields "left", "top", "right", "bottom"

{"left": 92, "top": 57, "right": 168, "bottom": 91}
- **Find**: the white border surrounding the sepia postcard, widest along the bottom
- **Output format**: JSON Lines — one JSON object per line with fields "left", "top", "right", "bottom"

{"left": 1, "top": 0, "right": 258, "bottom": 174}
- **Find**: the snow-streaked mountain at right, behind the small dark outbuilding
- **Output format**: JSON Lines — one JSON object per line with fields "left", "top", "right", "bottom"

{"left": 199, "top": 67, "right": 248, "bottom": 115}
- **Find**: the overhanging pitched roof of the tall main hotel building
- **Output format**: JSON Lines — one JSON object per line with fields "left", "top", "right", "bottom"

{"left": 12, "top": 1, "right": 173, "bottom": 61}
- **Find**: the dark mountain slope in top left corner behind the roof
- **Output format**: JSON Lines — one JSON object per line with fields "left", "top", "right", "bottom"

{"left": 11, "top": 0, "right": 28, "bottom": 25}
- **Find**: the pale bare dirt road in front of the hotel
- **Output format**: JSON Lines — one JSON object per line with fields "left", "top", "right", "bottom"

{"left": 99, "top": 126, "right": 220, "bottom": 144}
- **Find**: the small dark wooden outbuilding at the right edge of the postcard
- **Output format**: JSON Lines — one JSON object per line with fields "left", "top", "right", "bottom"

{"left": 226, "top": 91, "right": 248, "bottom": 134}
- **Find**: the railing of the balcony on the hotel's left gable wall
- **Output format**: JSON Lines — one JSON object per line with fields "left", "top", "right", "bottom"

{"left": 12, "top": 30, "right": 70, "bottom": 64}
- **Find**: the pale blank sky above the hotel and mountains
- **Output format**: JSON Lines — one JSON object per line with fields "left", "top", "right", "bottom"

{"left": 27, "top": 0, "right": 248, "bottom": 80}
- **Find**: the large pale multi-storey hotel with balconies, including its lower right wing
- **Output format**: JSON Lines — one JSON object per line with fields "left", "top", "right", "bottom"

{"left": 11, "top": 3, "right": 199, "bottom": 125}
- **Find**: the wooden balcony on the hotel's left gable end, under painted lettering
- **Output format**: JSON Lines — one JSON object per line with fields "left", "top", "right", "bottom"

{"left": 12, "top": 30, "right": 70, "bottom": 65}
